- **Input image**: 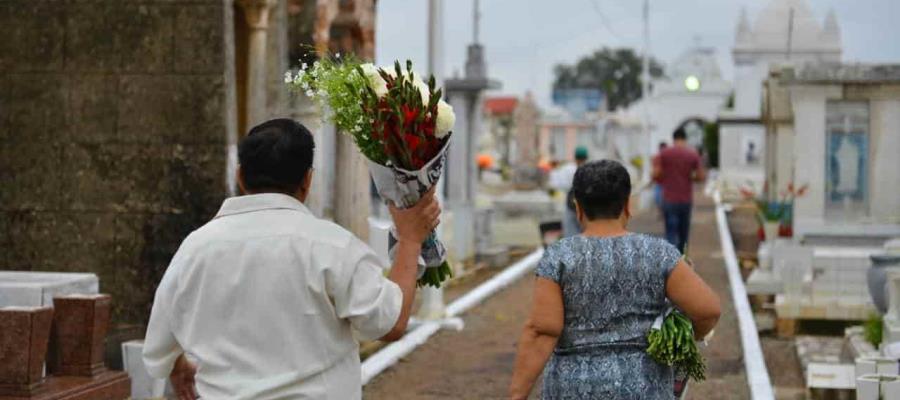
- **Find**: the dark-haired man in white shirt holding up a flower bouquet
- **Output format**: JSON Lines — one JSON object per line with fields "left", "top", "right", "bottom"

{"left": 143, "top": 119, "right": 440, "bottom": 400}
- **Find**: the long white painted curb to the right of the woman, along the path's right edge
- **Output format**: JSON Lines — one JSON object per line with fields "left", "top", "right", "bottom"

{"left": 713, "top": 190, "right": 775, "bottom": 400}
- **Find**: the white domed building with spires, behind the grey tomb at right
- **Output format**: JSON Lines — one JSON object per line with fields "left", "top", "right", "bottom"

{"left": 719, "top": 0, "right": 842, "bottom": 184}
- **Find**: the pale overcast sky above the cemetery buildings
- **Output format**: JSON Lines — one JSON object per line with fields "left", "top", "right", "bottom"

{"left": 376, "top": 0, "right": 900, "bottom": 105}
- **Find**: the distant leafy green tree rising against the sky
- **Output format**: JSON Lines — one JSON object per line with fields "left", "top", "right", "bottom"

{"left": 553, "top": 47, "right": 663, "bottom": 111}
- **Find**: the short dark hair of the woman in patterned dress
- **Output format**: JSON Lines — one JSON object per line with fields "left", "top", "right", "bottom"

{"left": 572, "top": 160, "right": 631, "bottom": 220}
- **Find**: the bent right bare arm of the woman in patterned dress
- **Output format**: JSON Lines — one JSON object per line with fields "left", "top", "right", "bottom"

{"left": 666, "top": 260, "right": 722, "bottom": 339}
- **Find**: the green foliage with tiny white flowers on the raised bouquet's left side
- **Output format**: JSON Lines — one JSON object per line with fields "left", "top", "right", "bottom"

{"left": 288, "top": 56, "right": 386, "bottom": 164}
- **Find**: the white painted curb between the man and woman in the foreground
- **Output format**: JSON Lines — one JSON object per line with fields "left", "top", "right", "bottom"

{"left": 361, "top": 249, "right": 544, "bottom": 385}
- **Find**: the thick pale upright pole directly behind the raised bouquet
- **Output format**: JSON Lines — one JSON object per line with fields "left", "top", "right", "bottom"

{"left": 417, "top": 0, "right": 450, "bottom": 319}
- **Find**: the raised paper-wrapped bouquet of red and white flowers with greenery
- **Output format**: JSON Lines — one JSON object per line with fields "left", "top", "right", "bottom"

{"left": 285, "top": 54, "right": 456, "bottom": 287}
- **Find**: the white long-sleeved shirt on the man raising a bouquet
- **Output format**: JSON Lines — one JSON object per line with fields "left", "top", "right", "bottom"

{"left": 145, "top": 194, "right": 402, "bottom": 399}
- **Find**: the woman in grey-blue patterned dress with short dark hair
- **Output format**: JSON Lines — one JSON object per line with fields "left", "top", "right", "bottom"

{"left": 510, "top": 160, "right": 720, "bottom": 400}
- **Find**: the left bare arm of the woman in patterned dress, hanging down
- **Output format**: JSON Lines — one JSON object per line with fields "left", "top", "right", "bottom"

{"left": 509, "top": 277, "right": 564, "bottom": 399}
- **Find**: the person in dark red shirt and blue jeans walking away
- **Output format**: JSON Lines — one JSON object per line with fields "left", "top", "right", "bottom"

{"left": 653, "top": 127, "right": 706, "bottom": 254}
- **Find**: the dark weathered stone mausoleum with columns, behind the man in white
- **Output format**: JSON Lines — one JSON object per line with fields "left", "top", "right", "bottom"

{"left": 0, "top": 0, "right": 375, "bottom": 336}
